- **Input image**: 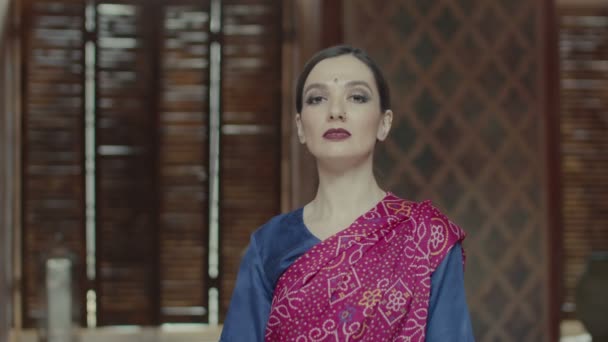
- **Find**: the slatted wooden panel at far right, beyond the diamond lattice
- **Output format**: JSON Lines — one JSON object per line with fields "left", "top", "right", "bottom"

{"left": 560, "top": 7, "right": 608, "bottom": 318}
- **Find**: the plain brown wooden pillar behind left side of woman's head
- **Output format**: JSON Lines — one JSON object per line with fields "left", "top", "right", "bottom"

{"left": 281, "top": 0, "right": 343, "bottom": 211}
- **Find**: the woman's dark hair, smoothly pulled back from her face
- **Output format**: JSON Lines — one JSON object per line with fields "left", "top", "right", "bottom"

{"left": 296, "top": 45, "right": 391, "bottom": 113}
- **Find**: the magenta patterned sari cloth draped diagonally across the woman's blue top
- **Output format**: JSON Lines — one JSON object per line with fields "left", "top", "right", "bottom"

{"left": 265, "top": 193, "right": 465, "bottom": 342}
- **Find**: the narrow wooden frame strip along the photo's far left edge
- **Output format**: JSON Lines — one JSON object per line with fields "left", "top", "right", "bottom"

{"left": 0, "top": 0, "right": 22, "bottom": 336}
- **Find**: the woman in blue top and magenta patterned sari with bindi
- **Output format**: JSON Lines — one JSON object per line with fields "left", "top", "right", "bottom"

{"left": 221, "top": 46, "right": 473, "bottom": 342}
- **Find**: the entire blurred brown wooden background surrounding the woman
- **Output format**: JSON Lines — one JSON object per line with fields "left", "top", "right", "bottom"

{"left": 0, "top": 0, "right": 608, "bottom": 342}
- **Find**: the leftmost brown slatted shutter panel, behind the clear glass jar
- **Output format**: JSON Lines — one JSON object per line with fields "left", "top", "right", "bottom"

{"left": 22, "top": 0, "right": 84, "bottom": 327}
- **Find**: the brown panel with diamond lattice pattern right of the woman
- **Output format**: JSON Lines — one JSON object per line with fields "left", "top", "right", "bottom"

{"left": 345, "top": 0, "right": 548, "bottom": 341}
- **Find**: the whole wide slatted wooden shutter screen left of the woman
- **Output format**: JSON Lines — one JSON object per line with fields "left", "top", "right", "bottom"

{"left": 23, "top": 0, "right": 281, "bottom": 327}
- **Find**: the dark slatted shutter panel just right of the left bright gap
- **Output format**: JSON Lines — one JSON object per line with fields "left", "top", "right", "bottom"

{"left": 96, "top": 1, "right": 158, "bottom": 325}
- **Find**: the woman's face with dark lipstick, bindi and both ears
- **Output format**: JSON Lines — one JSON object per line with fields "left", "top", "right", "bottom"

{"left": 296, "top": 55, "right": 393, "bottom": 162}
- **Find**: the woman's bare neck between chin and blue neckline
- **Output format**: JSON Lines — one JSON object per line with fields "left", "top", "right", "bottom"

{"left": 310, "top": 155, "right": 386, "bottom": 219}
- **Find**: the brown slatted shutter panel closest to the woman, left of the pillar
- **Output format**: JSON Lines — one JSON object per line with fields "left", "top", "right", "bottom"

{"left": 220, "top": 0, "right": 281, "bottom": 313}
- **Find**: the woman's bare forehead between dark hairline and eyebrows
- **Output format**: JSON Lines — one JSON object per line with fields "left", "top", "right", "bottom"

{"left": 306, "top": 55, "right": 375, "bottom": 88}
